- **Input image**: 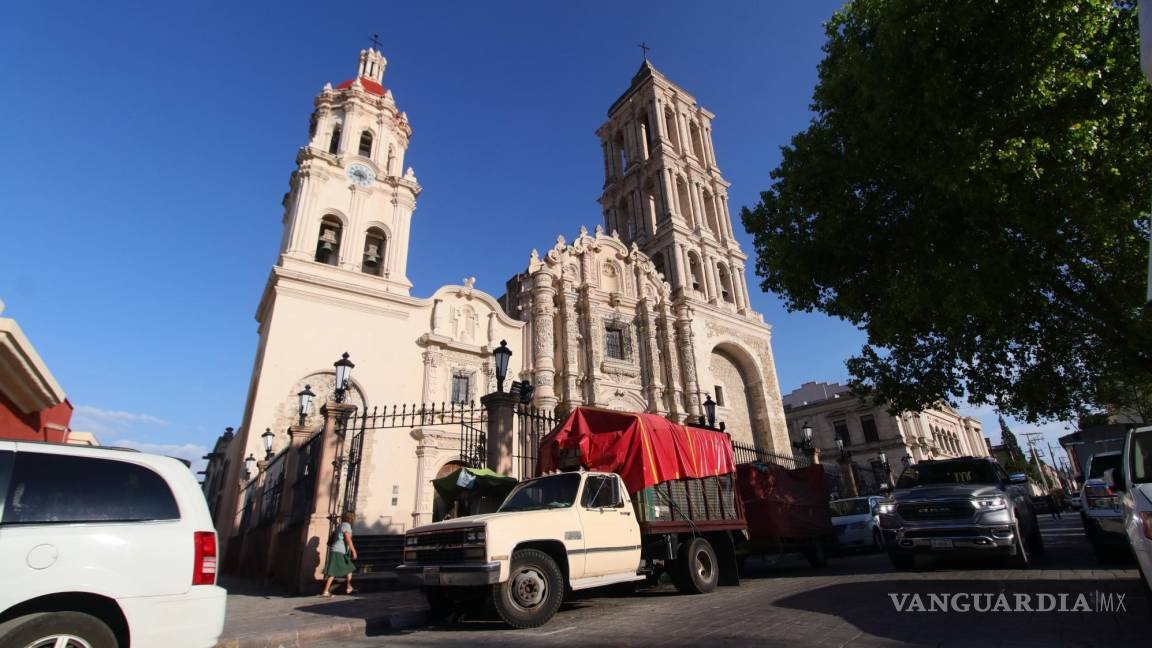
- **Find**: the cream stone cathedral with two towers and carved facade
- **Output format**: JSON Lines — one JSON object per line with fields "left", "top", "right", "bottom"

{"left": 217, "top": 48, "right": 790, "bottom": 537}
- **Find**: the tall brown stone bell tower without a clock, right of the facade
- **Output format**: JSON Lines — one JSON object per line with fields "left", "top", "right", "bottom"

{"left": 597, "top": 59, "right": 751, "bottom": 315}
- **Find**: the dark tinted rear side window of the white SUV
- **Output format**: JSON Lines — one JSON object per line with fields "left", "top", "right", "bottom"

{"left": 2, "top": 452, "right": 180, "bottom": 525}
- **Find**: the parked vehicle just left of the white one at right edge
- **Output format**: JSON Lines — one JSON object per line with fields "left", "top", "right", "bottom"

{"left": 1081, "top": 450, "right": 1129, "bottom": 562}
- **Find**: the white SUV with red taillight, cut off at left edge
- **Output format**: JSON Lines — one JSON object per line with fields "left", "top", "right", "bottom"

{"left": 0, "top": 440, "right": 226, "bottom": 648}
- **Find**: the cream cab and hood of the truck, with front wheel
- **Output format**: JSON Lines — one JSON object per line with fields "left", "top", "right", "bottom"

{"left": 396, "top": 470, "right": 644, "bottom": 627}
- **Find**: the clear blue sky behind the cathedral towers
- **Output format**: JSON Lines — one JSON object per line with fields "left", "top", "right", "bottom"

{"left": 0, "top": 0, "right": 1062, "bottom": 468}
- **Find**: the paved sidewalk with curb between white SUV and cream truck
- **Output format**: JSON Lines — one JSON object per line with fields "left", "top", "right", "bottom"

{"left": 218, "top": 579, "right": 427, "bottom": 648}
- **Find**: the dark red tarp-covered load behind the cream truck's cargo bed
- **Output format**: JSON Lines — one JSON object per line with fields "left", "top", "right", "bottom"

{"left": 736, "top": 464, "right": 833, "bottom": 540}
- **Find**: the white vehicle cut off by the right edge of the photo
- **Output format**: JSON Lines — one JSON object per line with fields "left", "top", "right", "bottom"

{"left": 1107, "top": 428, "right": 1152, "bottom": 592}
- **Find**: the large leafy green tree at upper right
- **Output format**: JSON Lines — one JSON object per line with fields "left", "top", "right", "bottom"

{"left": 742, "top": 0, "right": 1152, "bottom": 421}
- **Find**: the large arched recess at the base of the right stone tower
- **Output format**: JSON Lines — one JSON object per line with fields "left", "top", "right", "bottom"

{"left": 702, "top": 345, "right": 775, "bottom": 451}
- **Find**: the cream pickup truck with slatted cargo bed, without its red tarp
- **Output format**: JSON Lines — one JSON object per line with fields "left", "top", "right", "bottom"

{"left": 396, "top": 469, "right": 745, "bottom": 628}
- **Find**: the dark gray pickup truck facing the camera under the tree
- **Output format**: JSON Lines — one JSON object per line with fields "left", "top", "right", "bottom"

{"left": 880, "top": 457, "right": 1044, "bottom": 570}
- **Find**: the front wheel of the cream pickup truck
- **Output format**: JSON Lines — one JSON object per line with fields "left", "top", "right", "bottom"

{"left": 492, "top": 549, "right": 564, "bottom": 628}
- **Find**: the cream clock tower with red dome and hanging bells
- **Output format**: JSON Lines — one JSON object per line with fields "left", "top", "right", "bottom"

{"left": 278, "top": 50, "right": 420, "bottom": 295}
